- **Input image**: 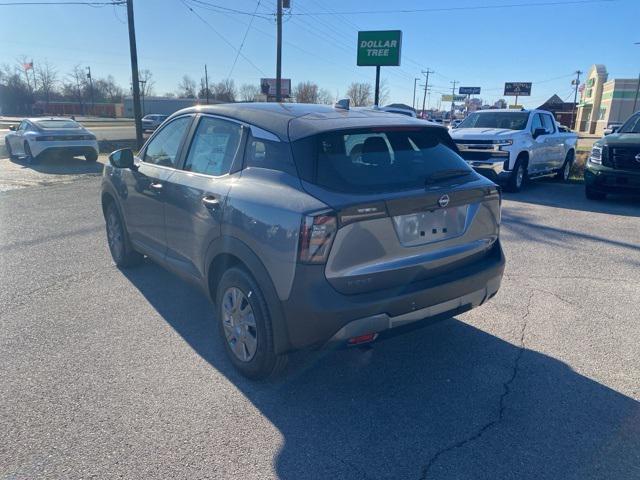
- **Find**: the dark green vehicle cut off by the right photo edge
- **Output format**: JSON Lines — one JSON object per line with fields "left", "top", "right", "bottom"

{"left": 584, "top": 112, "right": 640, "bottom": 200}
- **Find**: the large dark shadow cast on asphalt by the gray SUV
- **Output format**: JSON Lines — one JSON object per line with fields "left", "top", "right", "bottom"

{"left": 123, "top": 262, "right": 640, "bottom": 480}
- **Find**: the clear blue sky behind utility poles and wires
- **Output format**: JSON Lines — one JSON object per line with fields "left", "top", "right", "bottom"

{"left": 0, "top": 0, "right": 640, "bottom": 107}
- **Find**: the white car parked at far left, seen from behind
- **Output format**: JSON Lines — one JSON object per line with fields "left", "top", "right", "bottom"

{"left": 4, "top": 117, "right": 99, "bottom": 163}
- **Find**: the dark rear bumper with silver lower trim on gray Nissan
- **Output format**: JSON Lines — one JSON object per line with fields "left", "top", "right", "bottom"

{"left": 282, "top": 241, "right": 505, "bottom": 349}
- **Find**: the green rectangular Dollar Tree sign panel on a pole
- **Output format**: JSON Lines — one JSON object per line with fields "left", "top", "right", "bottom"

{"left": 358, "top": 30, "right": 402, "bottom": 67}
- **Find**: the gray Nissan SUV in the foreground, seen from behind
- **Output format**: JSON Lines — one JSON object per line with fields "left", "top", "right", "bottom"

{"left": 102, "top": 103, "right": 505, "bottom": 378}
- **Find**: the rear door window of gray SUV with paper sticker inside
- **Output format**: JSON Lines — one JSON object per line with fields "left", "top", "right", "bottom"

{"left": 184, "top": 117, "right": 242, "bottom": 176}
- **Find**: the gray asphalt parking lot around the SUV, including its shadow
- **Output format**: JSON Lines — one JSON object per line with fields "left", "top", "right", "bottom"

{"left": 0, "top": 157, "right": 640, "bottom": 480}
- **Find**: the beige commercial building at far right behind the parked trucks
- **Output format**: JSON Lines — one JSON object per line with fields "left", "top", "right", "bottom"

{"left": 576, "top": 65, "right": 640, "bottom": 135}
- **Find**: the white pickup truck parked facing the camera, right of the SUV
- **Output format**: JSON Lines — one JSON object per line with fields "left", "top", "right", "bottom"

{"left": 449, "top": 110, "right": 578, "bottom": 192}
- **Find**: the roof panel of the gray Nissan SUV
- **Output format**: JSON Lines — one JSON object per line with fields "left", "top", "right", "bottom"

{"left": 168, "top": 102, "right": 442, "bottom": 141}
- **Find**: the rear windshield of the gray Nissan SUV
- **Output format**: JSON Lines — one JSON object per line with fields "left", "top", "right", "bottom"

{"left": 293, "top": 127, "right": 471, "bottom": 193}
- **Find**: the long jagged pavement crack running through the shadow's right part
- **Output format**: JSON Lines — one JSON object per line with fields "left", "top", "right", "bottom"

{"left": 420, "top": 290, "right": 535, "bottom": 480}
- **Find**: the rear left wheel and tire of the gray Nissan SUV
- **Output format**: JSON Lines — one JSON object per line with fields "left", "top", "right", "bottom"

{"left": 216, "top": 267, "right": 286, "bottom": 379}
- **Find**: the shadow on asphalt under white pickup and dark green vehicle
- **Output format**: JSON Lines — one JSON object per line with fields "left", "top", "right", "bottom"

{"left": 504, "top": 179, "right": 640, "bottom": 217}
